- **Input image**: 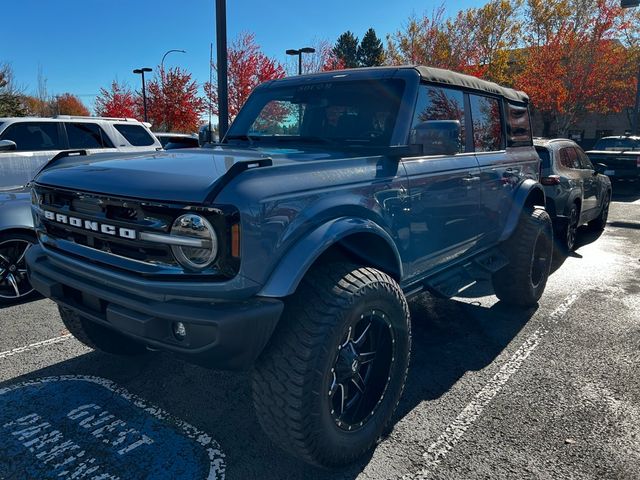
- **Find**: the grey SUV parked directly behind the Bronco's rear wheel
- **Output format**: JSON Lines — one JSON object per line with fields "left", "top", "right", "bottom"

{"left": 534, "top": 139, "right": 611, "bottom": 251}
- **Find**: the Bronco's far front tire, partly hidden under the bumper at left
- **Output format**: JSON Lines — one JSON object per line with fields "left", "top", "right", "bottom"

{"left": 58, "top": 307, "right": 148, "bottom": 356}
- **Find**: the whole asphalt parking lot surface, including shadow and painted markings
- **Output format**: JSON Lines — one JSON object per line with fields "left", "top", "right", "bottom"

{"left": 0, "top": 184, "right": 640, "bottom": 480}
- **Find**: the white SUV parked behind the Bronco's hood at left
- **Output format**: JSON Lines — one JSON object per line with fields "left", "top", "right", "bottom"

{"left": 0, "top": 115, "right": 162, "bottom": 190}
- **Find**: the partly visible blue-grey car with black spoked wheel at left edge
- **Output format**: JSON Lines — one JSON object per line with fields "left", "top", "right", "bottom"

{"left": 0, "top": 187, "right": 37, "bottom": 305}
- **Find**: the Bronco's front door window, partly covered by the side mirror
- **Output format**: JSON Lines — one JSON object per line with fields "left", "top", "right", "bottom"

{"left": 410, "top": 85, "right": 466, "bottom": 153}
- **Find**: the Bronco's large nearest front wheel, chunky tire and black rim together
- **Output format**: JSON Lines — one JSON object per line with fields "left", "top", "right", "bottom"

{"left": 253, "top": 264, "right": 411, "bottom": 467}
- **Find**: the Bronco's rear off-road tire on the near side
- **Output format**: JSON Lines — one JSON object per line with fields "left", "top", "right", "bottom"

{"left": 493, "top": 209, "right": 553, "bottom": 307}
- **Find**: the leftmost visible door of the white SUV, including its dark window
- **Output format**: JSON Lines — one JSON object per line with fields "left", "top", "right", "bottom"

{"left": 0, "top": 121, "right": 66, "bottom": 187}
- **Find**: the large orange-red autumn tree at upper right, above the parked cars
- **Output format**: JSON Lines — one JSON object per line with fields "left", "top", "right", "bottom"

{"left": 515, "top": 0, "right": 635, "bottom": 136}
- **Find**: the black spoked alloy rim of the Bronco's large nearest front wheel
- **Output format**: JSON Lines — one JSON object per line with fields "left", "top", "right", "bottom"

{"left": 328, "top": 310, "right": 395, "bottom": 430}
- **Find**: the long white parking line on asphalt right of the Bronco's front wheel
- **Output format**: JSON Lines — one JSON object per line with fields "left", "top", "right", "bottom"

{"left": 403, "top": 294, "right": 578, "bottom": 480}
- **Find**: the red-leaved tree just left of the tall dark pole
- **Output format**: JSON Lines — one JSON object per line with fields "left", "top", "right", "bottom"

{"left": 145, "top": 67, "right": 206, "bottom": 132}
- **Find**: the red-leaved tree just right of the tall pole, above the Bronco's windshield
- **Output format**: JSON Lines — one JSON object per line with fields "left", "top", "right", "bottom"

{"left": 204, "top": 33, "right": 285, "bottom": 120}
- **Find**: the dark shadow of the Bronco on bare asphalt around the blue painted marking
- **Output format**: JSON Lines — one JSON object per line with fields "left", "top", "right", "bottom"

{"left": 0, "top": 295, "right": 535, "bottom": 480}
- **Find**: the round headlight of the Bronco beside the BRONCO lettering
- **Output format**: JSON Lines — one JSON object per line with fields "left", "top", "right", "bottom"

{"left": 171, "top": 213, "right": 218, "bottom": 270}
